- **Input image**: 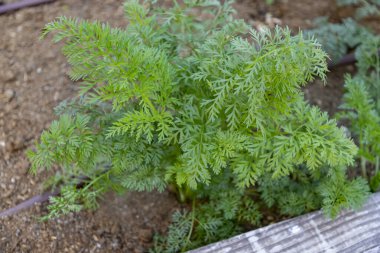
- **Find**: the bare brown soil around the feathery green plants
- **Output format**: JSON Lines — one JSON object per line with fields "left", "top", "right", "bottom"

{"left": 0, "top": 0, "right": 368, "bottom": 252}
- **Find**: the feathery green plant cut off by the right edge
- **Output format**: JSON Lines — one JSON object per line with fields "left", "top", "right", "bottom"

{"left": 339, "top": 35, "right": 380, "bottom": 184}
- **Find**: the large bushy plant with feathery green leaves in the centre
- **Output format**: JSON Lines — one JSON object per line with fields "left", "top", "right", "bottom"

{"left": 29, "top": 0, "right": 367, "bottom": 252}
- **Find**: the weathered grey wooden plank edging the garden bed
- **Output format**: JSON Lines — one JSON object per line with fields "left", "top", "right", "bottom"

{"left": 189, "top": 193, "right": 380, "bottom": 253}
